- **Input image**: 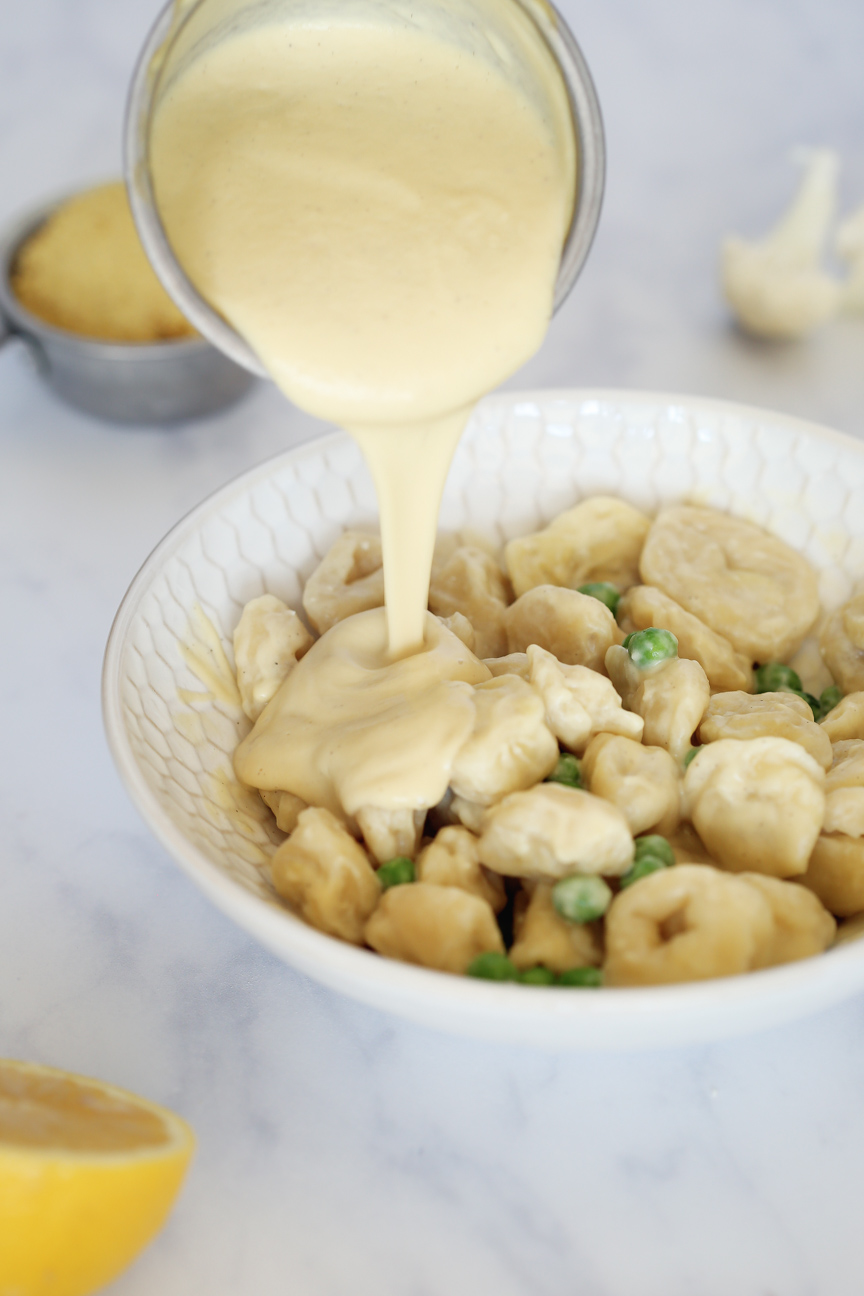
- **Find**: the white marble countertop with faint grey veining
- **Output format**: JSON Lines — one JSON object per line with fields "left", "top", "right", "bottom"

{"left": 0, "top": 0, "right": 864, "bottom": 1296}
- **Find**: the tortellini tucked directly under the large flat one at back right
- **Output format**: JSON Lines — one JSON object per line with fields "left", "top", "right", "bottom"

{"left": 618, "top": 584, "right": 753, "bottom": 692}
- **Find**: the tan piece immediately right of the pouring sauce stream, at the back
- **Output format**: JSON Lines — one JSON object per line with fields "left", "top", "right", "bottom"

{"left": 429, "top": 544, "right": 510, "bottom": 657}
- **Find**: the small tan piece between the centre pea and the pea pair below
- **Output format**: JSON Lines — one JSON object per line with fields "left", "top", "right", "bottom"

{"left": 582, "top": 734, "right": 681, "bottom": 837}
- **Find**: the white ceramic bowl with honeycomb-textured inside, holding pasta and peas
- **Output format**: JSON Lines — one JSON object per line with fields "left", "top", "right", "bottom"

{"left": 104, "top": 391, "right": 864, "bottom": 1048}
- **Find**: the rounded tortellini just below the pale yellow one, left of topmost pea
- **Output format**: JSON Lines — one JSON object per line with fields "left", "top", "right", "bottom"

{"left": 504, "top": 584, "right": 623, "bottom": 671}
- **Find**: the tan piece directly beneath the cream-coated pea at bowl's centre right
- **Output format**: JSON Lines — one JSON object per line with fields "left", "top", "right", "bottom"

{"left": 606, "top": 644, "right": 711, "bottom": 762}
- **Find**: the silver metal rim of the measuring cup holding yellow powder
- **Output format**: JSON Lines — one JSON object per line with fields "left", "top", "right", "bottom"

{"left": 0, "top": 184, "right": 216, "bottom": 363}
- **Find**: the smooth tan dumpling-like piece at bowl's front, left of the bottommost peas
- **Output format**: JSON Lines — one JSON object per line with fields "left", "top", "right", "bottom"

{"left": 365, "top": 883, "right": 504, "bottom": 973}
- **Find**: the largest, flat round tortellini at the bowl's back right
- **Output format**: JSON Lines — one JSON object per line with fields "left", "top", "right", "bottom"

{"left": 640, "top": 505, "right": 818, "bottom": 663}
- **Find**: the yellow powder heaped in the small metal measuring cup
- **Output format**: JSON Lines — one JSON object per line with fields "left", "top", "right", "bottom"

{"left": 12, "top": 181, "right": 194, "bottom": 342}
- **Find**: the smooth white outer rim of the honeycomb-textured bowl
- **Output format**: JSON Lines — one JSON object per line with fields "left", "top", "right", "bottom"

{"left": 101, "top": 388, "right": 864, "bottom": 1050}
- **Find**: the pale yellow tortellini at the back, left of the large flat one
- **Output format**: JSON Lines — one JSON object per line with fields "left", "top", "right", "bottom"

{"left": 504, "top": 495, "right": 650, "bottom": 597}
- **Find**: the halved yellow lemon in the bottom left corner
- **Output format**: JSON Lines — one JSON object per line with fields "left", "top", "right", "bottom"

{"left": 0, "top": 1059, "right": 194, "bottom": 1296}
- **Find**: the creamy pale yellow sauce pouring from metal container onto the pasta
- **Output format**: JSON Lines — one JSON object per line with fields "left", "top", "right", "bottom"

{"left": 150, "top": 0, "right": 575, "bottom": 814}
